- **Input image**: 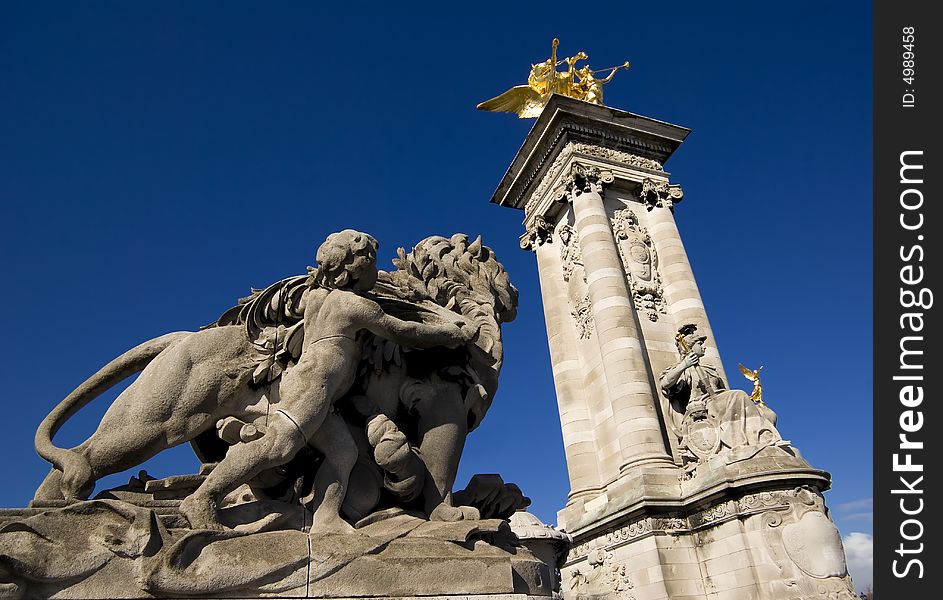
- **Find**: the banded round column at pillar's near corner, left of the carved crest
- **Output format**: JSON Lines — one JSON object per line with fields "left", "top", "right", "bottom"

{"left": 570, "top": 164, "right": 673, "bottom": 471}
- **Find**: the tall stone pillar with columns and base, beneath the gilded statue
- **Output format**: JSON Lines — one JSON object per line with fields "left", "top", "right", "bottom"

{"left": 492, "top": 96, "right": 856, "bottom": 600}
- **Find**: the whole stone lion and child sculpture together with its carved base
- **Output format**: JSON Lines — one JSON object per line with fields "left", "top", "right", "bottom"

{"left": 0, "top": 230, "right": 551, "bottom": 598}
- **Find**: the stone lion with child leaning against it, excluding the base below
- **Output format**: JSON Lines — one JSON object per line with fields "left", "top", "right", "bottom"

{"left": 34, "top": 230, "right": 517, "bottom": 527}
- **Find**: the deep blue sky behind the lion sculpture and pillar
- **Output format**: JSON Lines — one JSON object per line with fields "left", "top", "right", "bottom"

{"left": 0, "top": 2, "right": 872, "bottom": 548}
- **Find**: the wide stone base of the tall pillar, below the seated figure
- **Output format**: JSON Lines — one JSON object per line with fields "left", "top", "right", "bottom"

{"left": 561, "top": 449, "right": 857, "bottom": 600}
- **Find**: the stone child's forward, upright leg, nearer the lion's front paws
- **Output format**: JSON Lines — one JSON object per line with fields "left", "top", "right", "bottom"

{"left": 308, "top": 412, "right": 357, "bottom": 533}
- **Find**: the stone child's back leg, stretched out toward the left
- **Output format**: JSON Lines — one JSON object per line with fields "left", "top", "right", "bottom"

{"left": 180, "top": 411, "right": 306, "bottom": 530}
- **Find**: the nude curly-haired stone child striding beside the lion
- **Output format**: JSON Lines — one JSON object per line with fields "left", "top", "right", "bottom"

{"left": 180, "top": 229, "right": 474, "bottom": 532}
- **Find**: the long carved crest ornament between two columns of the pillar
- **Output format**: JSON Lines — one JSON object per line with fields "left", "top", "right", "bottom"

{"left": 612, "top": 208, "right": 668, "bottom": 321}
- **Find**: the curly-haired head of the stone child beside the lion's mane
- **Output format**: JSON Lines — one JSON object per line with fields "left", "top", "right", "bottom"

{"left": 308, "top": 229, "right": 379, "bottom": 291}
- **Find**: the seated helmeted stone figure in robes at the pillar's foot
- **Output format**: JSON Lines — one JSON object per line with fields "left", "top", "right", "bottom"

{"left": 659, "top": 324, "right": 781, "bottom": 453}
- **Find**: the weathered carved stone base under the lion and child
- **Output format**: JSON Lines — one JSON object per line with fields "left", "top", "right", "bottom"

{"left": 0, "top": 500, "right": 556, "bottom": 600}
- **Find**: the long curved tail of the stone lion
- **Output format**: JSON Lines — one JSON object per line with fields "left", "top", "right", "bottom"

{"left": 33, "top": 331, "right": 193, "bottom": 479}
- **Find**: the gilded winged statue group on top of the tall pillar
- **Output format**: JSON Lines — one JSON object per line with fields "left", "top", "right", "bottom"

{"left": 478, "top": 38, "right": 629, "bottom": 119}
